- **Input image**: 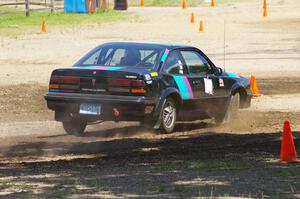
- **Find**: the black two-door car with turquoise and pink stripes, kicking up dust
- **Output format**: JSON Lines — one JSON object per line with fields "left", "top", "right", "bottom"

{"left": 45, "top": 42, "right": 252, "bottom": 135}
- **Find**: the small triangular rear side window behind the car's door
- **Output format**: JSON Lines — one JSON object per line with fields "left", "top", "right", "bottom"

{"left": 163, "top": 51, "right": 187, "bottom": 75}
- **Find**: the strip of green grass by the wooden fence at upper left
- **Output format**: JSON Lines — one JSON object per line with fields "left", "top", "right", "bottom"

{"left": 0, "top": 8, "right": 129, "bottom": 37}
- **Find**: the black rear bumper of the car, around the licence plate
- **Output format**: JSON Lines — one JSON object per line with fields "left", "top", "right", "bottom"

{"left": 45, "top": 92, "right": 156, "bottom": 121}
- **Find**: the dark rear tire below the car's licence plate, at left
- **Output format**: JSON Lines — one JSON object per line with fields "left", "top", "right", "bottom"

{"left": 62, "top": 118, "right": 87, "bottom": 136}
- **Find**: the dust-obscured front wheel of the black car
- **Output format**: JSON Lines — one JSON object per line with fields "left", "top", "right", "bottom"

{"left": 215, "top": 93, "right": 240, "bottom": 125}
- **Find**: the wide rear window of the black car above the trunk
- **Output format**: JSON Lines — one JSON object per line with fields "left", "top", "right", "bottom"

{"left": 75, "top": 44, "right": 163, "bottom": 68}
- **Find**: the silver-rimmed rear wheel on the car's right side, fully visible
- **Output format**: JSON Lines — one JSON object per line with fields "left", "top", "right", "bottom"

{"left": 160, "top": 98, "right": 177, "bottom": 133}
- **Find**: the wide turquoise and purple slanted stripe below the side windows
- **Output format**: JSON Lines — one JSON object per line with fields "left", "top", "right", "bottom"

{"left": 173, "top": 75, "right": 194, "bottom": 99}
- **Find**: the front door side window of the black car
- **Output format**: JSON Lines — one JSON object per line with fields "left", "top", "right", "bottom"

{"left": 180, "top": 50, "right": 211, "bottom": 75}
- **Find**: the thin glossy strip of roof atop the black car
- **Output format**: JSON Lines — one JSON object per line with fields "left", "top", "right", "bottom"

{"left": 103, "top": 42, "right": 195, "bottom": 50}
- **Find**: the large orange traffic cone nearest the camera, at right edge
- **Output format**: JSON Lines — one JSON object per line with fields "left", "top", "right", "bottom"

{"left": 280, "top": 121, "right": 299, "bottom": 162}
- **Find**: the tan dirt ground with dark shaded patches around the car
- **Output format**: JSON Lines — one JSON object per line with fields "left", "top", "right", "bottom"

{"left": 0, "top": 0, "right": 300, "bottom": 198}
